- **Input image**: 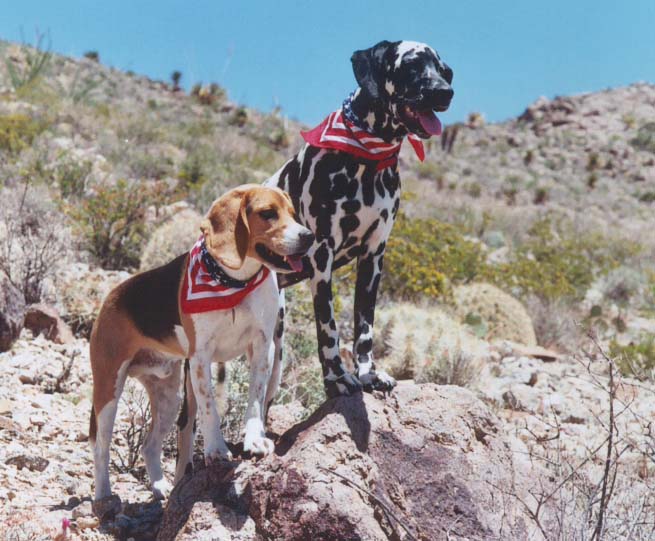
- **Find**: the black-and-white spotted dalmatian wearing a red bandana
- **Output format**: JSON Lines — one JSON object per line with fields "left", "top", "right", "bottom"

{"left": 265, "top": 41, "right": 453, "bottom": 397}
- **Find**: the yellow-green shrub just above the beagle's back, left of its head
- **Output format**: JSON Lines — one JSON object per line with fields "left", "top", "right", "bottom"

{"left": 66, "top": 180, "right": 166, "bottom": 269}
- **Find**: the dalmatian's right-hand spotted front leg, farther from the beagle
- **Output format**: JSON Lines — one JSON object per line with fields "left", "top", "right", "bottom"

{"left": 353, "top": 242, "right": 396, "bottom": 392}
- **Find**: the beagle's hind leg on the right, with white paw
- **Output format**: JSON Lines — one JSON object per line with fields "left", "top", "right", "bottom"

{"left": 139, "top": 354, "right": 181, "bottom": 500}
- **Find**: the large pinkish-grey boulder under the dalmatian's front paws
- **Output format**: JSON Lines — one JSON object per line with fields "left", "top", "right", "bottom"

{"left": 158, "top": 383, "right": 549, "bottom": 541}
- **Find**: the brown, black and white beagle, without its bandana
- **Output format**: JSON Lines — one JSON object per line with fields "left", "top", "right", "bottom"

{"left": 89, "top": 184, "right": 314, "bottom": 500}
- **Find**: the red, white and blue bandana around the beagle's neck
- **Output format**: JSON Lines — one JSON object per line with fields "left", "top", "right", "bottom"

{"left": 180, "top": 237, "right": 270, "bottom": 314}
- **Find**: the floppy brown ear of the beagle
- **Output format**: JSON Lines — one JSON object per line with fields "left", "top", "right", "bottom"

{"left": 200, "top": 190, "right": 250, "bottom": 269}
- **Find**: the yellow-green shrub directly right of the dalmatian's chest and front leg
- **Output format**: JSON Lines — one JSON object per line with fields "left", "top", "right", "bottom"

{"left": 382, "top": 214, "right": 486, "bottom": 299}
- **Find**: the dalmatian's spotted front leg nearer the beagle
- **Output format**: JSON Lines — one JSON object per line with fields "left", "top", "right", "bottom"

{"left": 310, "top": 240, "right": 362, "bottom": 398}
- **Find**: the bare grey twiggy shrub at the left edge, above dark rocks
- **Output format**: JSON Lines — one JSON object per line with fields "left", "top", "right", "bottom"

{"left": 0, "top": 184, "right": 70, "bottom": 303}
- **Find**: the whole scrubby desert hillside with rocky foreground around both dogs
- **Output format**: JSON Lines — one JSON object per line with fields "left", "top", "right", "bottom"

{"left": 0, "top": 41, "right": 655, "bottom": 540}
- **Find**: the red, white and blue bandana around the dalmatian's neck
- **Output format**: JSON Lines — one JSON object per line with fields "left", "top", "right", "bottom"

{"left": 300, "top": 109, "right": 425, "bottom": 171}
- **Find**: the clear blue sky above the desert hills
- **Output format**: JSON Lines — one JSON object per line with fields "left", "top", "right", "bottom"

{"left": 0, "top": 0, "right": 655, "bottom": 124}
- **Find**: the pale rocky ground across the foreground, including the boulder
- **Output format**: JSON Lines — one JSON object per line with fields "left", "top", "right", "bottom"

{"left": 0, "top": 320, "right": 655, "bottom": 540}
